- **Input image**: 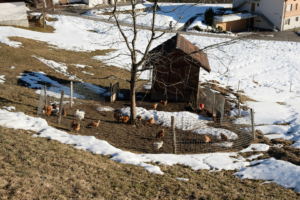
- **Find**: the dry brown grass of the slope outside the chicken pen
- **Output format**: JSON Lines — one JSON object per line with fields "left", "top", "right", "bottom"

{"left": 0, "top": 35, "right": 299, "bottom": 199}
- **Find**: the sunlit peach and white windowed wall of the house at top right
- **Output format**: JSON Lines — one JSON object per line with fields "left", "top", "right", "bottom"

{"left": 283, "top": 0, "right": 300, "bottom": 30}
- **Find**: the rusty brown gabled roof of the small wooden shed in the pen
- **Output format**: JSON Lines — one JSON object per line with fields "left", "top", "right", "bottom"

{"left": 149, "top": 33, "right": 211, "bottom": 72}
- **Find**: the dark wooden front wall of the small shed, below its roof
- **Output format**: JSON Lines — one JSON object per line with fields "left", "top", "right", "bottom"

{"left": 151, "top": 51, "right": 199, "bottom": 101}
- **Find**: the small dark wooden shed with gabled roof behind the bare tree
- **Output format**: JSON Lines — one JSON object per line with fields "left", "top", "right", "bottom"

{"left": 145, "top": 34, "right": 211, "bottom": 101}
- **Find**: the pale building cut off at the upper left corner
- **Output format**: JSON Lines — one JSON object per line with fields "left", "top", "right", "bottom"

{"left": 0, "top": 0, "right": 29, "bottom": 27}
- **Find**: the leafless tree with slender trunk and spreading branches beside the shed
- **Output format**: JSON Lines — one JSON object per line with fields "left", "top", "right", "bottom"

{"left": 97, "top": 0, "right": 249, "bottom": 123}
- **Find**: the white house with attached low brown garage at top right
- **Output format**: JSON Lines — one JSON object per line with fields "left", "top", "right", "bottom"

{"left": 215, "top": 0, "right": 300, "bottom": 32}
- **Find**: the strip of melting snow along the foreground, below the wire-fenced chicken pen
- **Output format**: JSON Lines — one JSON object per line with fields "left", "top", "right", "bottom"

{"left": 0, "top": 107, "right": 300, "bottom": 192}
